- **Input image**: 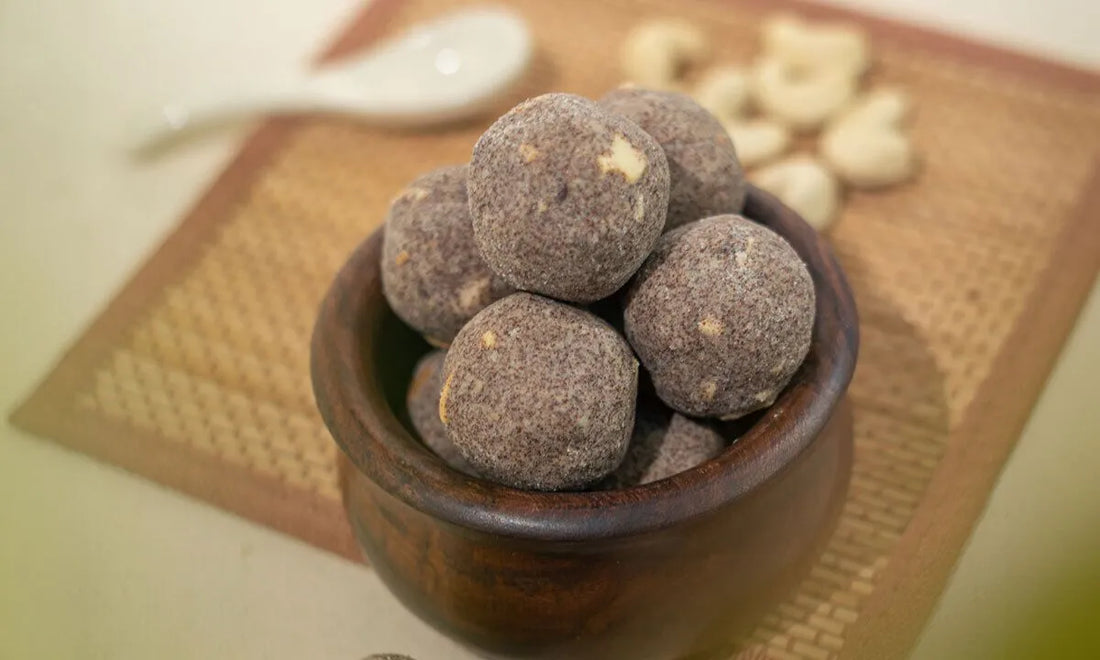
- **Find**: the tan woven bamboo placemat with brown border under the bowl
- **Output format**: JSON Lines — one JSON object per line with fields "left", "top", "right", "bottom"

{"left": 13, "top": 0, "right": 1100, "bottom": 659}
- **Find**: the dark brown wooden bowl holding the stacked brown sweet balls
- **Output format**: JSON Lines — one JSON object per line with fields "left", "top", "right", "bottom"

{"left": 311, "top": 189, "right": 858, "bottom": 660}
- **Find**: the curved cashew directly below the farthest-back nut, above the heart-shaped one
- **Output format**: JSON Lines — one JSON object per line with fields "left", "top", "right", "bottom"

{"left": 752, "top": 57, "right": 856, "bottom": 131}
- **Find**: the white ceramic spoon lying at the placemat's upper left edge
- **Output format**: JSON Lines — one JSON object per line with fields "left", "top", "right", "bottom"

{"left": 130, "top": 8, "right": 534, "bottom": 149}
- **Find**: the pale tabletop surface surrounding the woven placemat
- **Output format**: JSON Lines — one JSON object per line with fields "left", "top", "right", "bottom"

{"left": 0, "top": 0, "right": 1100, "bottom": 660}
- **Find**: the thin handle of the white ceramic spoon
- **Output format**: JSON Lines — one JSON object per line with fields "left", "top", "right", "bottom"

{"left": 135, "top": 79, "right": 364, "bottom": 151}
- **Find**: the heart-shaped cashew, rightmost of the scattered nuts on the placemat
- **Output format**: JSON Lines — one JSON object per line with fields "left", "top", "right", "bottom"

{"left": 818, "top": 90, "right": 917, "bottom": 188}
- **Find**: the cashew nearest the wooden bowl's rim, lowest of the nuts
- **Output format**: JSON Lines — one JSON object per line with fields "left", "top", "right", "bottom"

{"left": 749, "top": 155, "right": 840, "bottom": 231}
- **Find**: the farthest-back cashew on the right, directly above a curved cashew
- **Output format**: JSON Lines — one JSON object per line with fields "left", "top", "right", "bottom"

{"left": 761, "top": 14, "right": 871, "bottom": 77}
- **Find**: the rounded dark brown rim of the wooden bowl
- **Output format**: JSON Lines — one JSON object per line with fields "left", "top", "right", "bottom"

{"left": 310, "top": 186, "right": 859, "bottom": 541}
